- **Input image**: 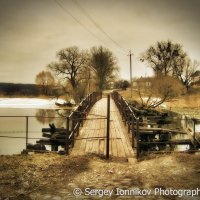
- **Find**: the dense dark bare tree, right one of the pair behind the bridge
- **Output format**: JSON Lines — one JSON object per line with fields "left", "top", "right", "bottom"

{"left": 91, "top": 46, "right": 118, "bottom": 90}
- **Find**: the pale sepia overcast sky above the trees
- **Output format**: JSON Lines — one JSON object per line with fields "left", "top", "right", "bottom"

{"left": 0, "top": 0, "right": 200, "bottom": 83}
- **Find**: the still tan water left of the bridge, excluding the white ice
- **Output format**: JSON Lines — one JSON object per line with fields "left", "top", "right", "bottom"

{"left": 0, "top": 108, "right": 74, "bottom": 155}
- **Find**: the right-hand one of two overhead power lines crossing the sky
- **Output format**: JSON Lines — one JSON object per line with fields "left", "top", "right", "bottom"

{"left": 72, "top": 0, "right": 126, "bottom": 52}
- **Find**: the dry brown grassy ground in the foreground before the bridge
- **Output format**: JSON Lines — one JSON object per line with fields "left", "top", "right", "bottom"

{"left": 0, "top": 153, "right": 200, "bottom": 200}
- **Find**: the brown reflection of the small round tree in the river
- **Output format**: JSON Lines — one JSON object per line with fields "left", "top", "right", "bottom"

{"left": 35, "top": 109, "right": 56, "bottom": 124}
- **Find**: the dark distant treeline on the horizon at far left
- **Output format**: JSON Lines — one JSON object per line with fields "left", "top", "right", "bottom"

{"left": 0, "top": 83, "right": 40, "bottom": 96}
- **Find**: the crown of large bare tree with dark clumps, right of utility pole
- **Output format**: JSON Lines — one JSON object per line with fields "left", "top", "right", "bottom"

{"left": 140, "top": 41, "right": 198, "bottom": 90}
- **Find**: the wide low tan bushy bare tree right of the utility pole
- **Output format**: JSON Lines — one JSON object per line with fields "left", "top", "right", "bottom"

{"left": 137, "top": 76, "right": 183, "bottom": 108}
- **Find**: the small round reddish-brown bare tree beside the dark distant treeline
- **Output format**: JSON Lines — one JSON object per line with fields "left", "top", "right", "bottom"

{"left": 35, "top": 71, "right": 55, "bottom": 95}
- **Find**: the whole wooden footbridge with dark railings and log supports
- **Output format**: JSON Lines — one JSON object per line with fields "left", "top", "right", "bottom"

{"left": 35, "top": 92, "right": 200, "bottom": 159}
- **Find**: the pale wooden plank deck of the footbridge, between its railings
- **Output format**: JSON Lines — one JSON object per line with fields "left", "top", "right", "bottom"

{"left": 71, "top": 98, "right": 135, "bottom": 158}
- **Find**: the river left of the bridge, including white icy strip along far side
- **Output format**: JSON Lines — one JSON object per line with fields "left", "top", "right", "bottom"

{"left": 0, "top": 99, "right": 69, "bottom": 155}
